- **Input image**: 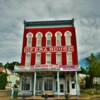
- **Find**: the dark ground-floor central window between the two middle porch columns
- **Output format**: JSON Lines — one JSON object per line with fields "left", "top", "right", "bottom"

{"left": 44, "top": 78, "right": 53, "bottom": 91}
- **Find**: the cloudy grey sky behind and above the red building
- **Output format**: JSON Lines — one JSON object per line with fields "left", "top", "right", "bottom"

{"left": 0, "top": 0, "right": 100, "bottom": 63}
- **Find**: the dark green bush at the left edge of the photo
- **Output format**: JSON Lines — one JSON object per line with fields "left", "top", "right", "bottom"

{"left": 0, "top": 72, "right": 7, "bottom": 90}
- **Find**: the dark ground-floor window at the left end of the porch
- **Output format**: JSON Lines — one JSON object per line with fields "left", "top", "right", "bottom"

{"left": 21, "top": 76, "right": 31, "bottom": 90}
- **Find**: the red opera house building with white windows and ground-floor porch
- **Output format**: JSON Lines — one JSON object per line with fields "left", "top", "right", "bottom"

{"left": 15, "top": 19, "right": 79, "bottom": 96}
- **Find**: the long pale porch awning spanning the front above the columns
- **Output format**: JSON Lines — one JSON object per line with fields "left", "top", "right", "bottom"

{"left": 14, "top": 65, "right": 80, "bottom": 72}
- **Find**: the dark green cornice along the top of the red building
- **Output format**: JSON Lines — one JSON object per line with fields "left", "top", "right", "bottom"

{"left": 24, "top": 18, "right": 74, "bottom": 28}
